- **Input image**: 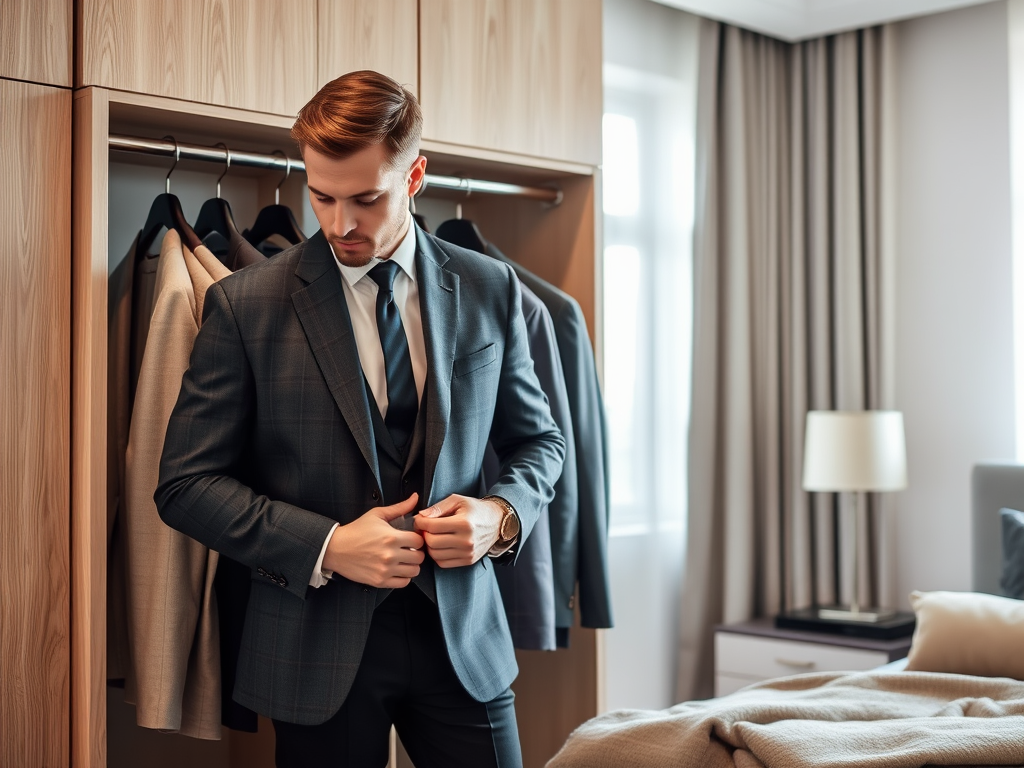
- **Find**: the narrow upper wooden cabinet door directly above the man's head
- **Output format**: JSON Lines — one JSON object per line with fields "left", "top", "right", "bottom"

{"left": 310, "top": 0, "right": 419, "bottom": 95}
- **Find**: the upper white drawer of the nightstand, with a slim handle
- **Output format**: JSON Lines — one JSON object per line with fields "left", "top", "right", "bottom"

{"left": 715, "top": 632, "right": 889, "bottom": 682}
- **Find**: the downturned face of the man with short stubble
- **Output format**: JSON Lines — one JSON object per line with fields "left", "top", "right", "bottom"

{"left": 302, "top": 144, "right": 427, "bottom": 266}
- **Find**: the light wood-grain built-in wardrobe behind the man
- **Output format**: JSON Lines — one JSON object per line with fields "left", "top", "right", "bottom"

{"left": 0, "top": 0, "right": 603, "bottom": 768}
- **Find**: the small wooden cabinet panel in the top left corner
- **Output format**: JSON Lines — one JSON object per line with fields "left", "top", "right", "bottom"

{"left": 0, "top": 0, "right": 72, "bottom": 87}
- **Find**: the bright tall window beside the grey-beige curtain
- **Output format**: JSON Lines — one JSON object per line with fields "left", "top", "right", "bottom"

{"left": 602, "top": 73, "right": 693, "bottom": 537}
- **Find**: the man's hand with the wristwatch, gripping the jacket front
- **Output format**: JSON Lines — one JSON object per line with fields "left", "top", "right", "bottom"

{"left": 416, "top": 495, "right": 505, "bottom": 568}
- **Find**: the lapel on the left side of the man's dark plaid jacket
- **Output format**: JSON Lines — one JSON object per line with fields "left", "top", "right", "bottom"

{"left": 292, "top": 232, "right": 380, "bottom": 485}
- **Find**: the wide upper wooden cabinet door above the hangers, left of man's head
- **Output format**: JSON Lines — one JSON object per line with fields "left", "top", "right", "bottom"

{"left": 78, "top": 0, "right": 316, "bottom": 116}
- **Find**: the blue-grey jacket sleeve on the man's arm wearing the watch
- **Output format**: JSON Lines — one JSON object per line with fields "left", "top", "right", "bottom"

{"left": 487, "top": 267, "right": 565, "bottom": 559}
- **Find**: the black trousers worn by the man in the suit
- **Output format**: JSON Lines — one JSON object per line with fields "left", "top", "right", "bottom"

{"left": 273, "top": 585, "right": 522, "bottom": 768}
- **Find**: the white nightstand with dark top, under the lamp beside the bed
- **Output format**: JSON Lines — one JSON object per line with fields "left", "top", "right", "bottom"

{"left": 715, "top": 618, "right": 910, "bottom": 696}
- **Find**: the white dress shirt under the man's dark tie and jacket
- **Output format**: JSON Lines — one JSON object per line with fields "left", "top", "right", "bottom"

{"left": 309, "top": 216, "right": 427, "bottom": 587}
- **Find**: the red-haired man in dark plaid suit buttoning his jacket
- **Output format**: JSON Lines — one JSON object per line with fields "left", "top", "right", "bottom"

{"left": 156, "top": 72, "right": 564, "bottom": 768}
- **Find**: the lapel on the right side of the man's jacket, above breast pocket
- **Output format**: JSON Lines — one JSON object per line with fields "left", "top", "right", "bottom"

{"left": 416, "top": 228, "right": 459, "bottom": 506}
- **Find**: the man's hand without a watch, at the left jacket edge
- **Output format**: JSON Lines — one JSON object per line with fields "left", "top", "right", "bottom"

{"left": 324, "top": 494, "right": 424, "bottom": 589}
